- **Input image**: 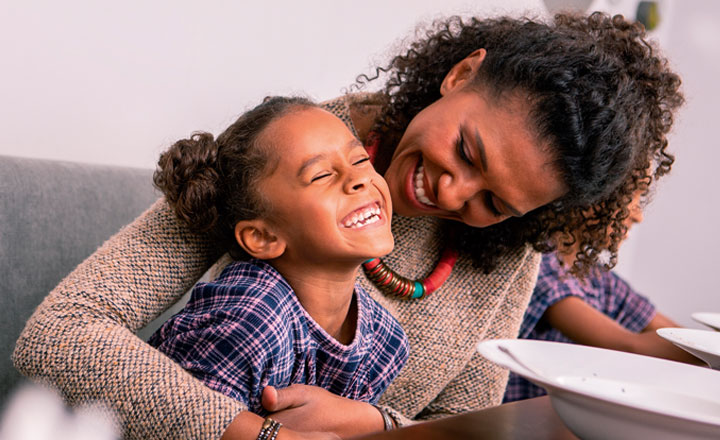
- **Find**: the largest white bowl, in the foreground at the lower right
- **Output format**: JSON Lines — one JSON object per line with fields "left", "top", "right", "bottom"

{"left": 478, "top": 339, "right": 720, "bottom": 440}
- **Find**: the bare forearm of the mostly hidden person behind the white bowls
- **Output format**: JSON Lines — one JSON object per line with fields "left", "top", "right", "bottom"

{"left": 543, "top": 296, "right": 701, "bottom": 365}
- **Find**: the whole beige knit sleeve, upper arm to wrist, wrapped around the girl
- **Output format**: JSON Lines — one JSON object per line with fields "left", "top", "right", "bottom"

{"left": 13, "top": 200, "right": 245, "bottom": 439}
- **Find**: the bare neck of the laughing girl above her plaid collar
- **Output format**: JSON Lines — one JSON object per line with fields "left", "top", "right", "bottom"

{"left": 271, "top": 260, "right": 358, "bottom": 345}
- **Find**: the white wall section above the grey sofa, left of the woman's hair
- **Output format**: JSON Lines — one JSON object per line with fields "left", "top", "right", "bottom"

{"left": 0, "top": 0, "right": 542, "bottom": 168}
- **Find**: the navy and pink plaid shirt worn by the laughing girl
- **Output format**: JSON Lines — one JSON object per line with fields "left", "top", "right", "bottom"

{"left": 148, "top": 260, "right": 408, "bottom": 415}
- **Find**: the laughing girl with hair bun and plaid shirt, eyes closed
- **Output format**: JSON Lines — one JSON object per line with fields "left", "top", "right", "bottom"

{"left": 149, "top": 97, "right": 408, "bottom": 438}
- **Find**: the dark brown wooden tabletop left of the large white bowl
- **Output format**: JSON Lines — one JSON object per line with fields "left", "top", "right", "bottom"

{"left": 361, "top": 396, "right": 577, "bottom": 440}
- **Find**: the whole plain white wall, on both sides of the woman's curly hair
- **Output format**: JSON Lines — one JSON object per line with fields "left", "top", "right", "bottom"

{"left": 0, "top": 0, "right": 720, "bottom": 326}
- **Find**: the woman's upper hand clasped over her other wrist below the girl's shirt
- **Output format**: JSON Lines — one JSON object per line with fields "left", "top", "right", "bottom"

{"left": 262, "top": 384, "right": 384, "bottom": 438}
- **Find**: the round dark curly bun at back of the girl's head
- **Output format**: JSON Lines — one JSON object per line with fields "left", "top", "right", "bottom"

{"left": 153, "top": 132, "right": 220, "bottom": 232}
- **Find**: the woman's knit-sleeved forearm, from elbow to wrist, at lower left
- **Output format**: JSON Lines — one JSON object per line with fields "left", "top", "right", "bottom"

{"left": 15, "top": 308, "right": 244, "bottom": 439}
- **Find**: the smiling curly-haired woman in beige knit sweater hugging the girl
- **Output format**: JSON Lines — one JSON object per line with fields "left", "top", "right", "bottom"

{"left": 14, "top": 14, "right": 682, "bottom": 439}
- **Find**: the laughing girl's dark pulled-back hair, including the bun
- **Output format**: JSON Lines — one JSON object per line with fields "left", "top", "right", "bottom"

{"left": 153, "top": 96, "right": 317, "bottom": 259}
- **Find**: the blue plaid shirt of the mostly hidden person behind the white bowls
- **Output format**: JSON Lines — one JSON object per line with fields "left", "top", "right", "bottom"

{"left": 503, "top": 254, "right": 655, "bottom": 403}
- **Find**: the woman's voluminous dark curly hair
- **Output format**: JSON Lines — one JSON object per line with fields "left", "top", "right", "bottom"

{"left": 356, "top": 13, "right": 683, "bottom": 275}
